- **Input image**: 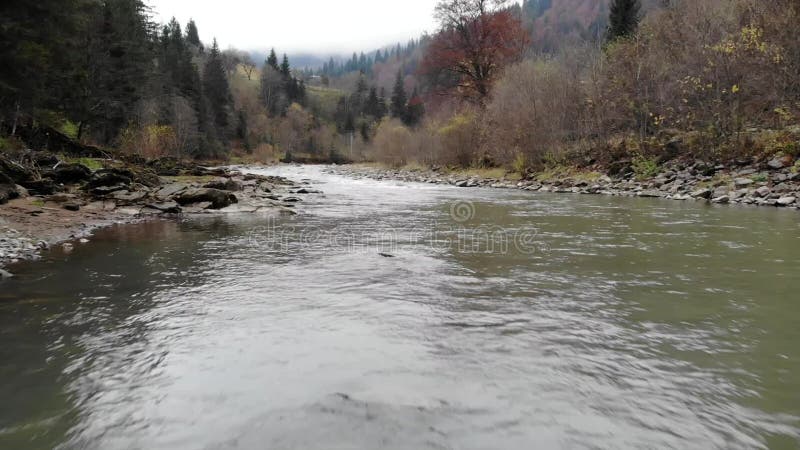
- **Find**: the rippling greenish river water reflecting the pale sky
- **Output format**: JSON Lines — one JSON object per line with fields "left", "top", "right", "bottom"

{"left": 0, "top": 166, "right": 800, "bottom": 450}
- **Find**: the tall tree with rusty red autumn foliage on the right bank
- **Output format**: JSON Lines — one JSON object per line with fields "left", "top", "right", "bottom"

{"left": 422, "top": 0, "right": 530, "bottom": 106}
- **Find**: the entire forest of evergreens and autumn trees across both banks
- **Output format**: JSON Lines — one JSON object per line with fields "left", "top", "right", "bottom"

{"left": 0, "top": 0, "right": 800, "bottom": 174}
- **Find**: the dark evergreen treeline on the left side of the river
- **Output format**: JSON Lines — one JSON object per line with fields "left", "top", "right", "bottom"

{"left": 0, "top": 0, "right": 314, "bottom": 162}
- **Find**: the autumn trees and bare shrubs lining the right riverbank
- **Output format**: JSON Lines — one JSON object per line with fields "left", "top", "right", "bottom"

{"left": 366, "top": 0, "right": 800, "bottom": 171}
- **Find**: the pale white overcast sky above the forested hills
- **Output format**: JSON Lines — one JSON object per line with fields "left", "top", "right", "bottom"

{"left": 148, "top": 0, "right": 436, "bottom": 53}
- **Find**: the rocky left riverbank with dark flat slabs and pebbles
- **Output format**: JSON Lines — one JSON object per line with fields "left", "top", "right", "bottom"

{"left": 0, "top": 153, "right": 317, "bottom": 268}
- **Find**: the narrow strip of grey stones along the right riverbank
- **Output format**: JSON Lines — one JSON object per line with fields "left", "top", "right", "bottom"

{"left": 329, "top": 158, "right": 800, "bottom": 209}
